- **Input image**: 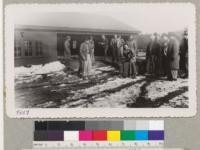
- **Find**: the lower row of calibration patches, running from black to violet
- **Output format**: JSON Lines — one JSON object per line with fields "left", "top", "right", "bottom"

{"left": 34, "top": 130, "right": 164, "bottom": 141}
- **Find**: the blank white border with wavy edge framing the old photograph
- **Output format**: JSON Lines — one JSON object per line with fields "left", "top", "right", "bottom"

{"left": 4, "top": 2, "right": 197, "bottom": 118}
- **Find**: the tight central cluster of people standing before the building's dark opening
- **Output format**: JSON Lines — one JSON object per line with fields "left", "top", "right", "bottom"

{"left": 110, "top": 35, "right": 137, "bottom": 78}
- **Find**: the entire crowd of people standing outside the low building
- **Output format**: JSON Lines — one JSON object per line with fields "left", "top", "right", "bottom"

{"left": 64, "top": 31, "right": 188, "bottom": 80}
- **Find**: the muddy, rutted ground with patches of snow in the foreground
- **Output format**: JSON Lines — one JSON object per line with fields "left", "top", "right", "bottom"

{"left": 15, "top": 61, "right": 188, "bottom": 108}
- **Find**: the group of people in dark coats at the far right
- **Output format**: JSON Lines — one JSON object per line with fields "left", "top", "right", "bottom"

{"left": 146, "top": 31, "right": 188, "bottom": 80}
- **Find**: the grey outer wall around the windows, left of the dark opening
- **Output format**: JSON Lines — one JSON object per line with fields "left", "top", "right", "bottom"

{"left": 15, "top": 30, "right": 57, "bottom": 66}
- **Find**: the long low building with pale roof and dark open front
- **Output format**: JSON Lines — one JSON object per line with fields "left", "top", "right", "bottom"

{"left": 14, "top": 13, "right": 139, "bottom": 66}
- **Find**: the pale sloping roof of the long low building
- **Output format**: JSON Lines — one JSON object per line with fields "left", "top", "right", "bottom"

{"left": 15, "top": 12, "right": 139, "bottom": 33}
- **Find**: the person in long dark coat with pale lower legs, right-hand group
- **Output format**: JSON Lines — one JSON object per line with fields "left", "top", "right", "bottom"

{"left": 167, "top": 35, "right": 179, "bottom": 81}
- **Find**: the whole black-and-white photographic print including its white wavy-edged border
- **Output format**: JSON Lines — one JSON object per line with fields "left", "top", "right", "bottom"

{"left": 5, "top": 3, "right": 196, "bottom": 117}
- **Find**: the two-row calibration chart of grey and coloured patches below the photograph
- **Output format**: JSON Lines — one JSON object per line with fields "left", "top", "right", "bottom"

{"left": 34, "top": 120, "right": 164, "bottom": 141}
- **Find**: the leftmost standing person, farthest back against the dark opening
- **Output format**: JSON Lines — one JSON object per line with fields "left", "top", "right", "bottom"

{"left": 64, "top": 36, "right": 71, "bottom": 66}
